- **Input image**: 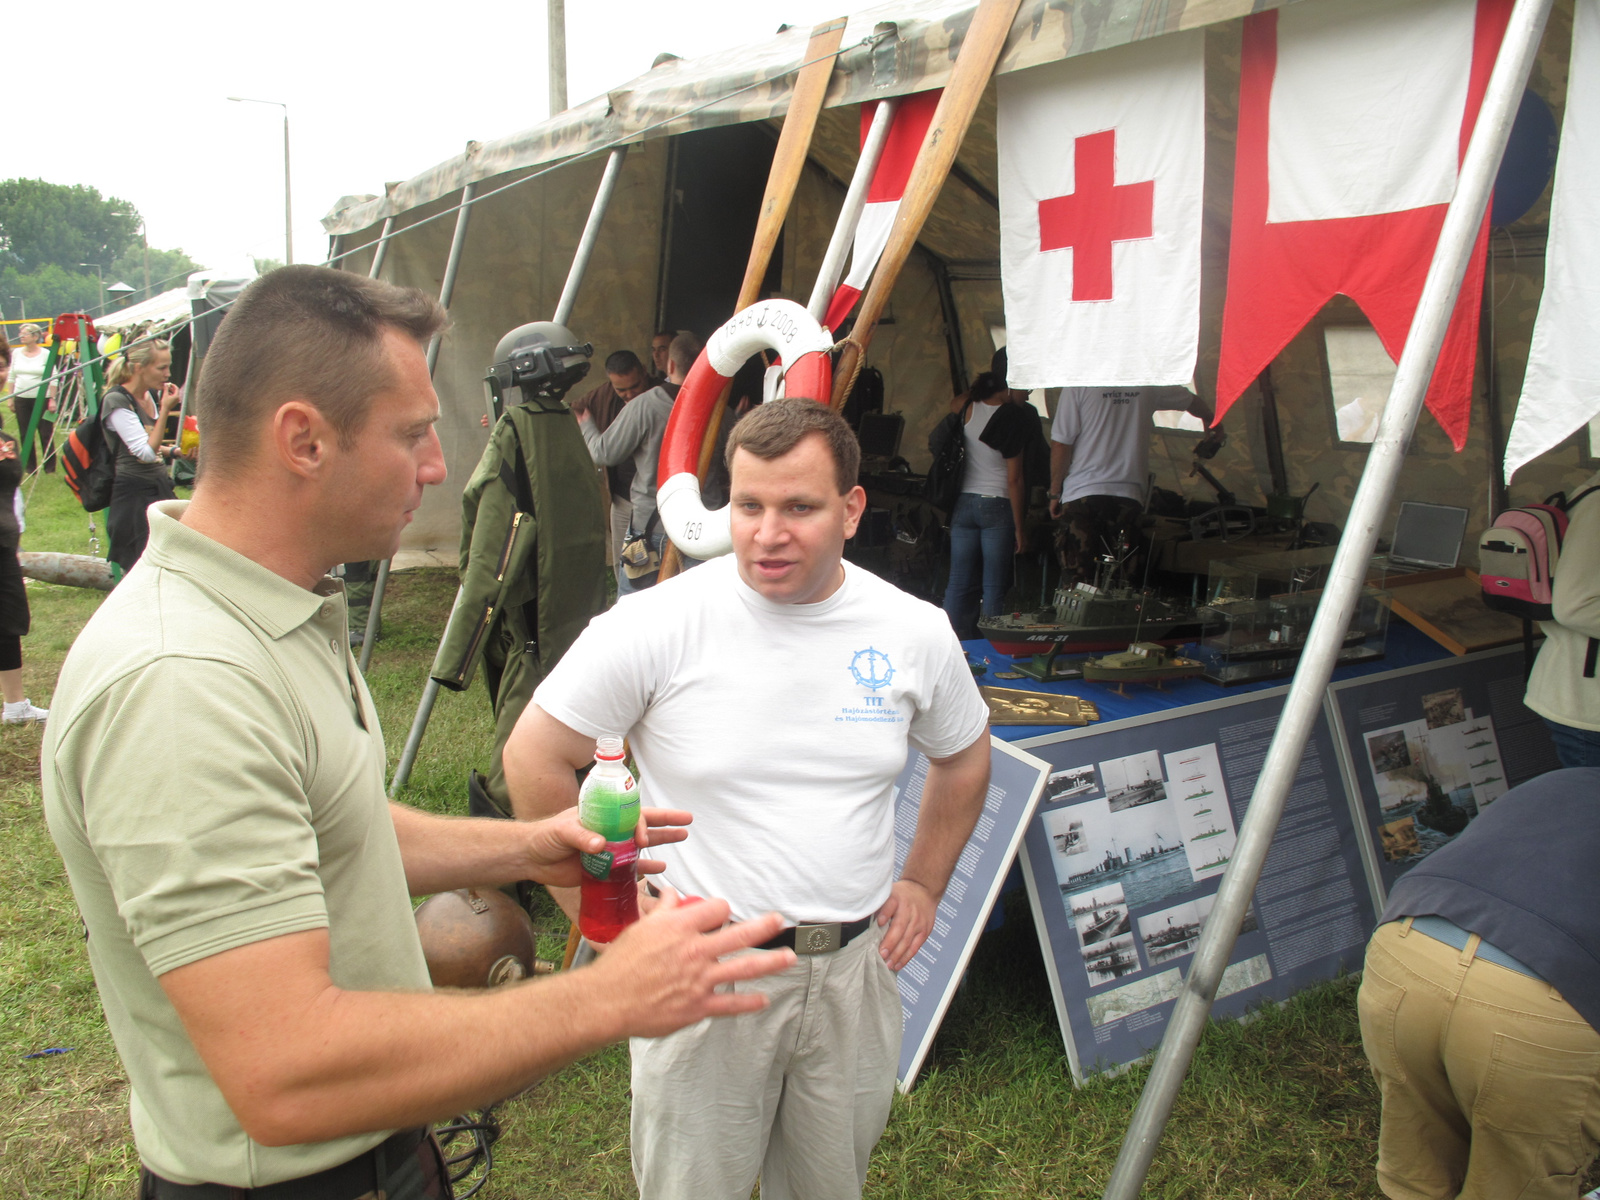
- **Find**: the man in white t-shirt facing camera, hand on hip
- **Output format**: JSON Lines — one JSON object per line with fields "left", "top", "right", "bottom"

{"left": 506, "top": 400, "right": 989, "bottom": 1200}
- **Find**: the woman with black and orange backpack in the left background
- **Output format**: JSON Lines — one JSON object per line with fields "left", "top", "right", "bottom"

{"left": 101, "top": 341, "right": 181, "bottom": 571}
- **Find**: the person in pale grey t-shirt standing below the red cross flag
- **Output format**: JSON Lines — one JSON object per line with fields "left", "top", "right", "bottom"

{"left": 1050, "top": 387, "right": 1221, "bottom": 587}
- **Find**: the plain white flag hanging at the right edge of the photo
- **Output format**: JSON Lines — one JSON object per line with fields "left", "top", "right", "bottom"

{"left": 1506, "top": 0, "right": 1600, "bottom": 482}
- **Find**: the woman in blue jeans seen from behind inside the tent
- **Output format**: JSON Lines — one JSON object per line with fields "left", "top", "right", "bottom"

{"left": 941, "top": 371, "right": 1027, "bottom": 637}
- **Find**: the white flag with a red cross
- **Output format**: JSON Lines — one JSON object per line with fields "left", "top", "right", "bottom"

{"left": 997, "top": 30, "right": 1205, "bottom": 389}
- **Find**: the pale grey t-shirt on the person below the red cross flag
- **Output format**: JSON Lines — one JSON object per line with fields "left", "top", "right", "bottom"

{"left": 1050, "top": 387, "right": 1194, "bottom": 504}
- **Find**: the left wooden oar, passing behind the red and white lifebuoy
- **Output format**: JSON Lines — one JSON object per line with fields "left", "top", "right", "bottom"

{"left": 658, "top": 18, "right": 846, "bottom": 579}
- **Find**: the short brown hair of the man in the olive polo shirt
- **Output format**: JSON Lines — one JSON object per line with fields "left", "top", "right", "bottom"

{"left": 197, "top": 266, "right": 448, "bottom": 474}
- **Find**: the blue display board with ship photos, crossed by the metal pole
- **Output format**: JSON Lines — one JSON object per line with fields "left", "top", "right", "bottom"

{"left": 1019, "top": 688, "right": 1374, "bottom": 1083}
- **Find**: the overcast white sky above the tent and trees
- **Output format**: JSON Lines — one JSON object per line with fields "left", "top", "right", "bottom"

{"left": 12, "top": 0, "right": 844, "bottom": 285}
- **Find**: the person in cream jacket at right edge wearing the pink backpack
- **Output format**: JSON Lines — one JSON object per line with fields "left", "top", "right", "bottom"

{"left": 1526, "top": 475, "right": 1600, "bottom": 766}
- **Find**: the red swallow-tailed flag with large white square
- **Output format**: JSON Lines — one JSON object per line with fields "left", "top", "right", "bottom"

{"left": 1216, "top": 0, "right": 1512, "bottom": 450}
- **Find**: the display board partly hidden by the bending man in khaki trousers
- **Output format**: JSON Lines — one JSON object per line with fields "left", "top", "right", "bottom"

{"left": 1328, "top": 646, "right": 1560, "bottom": 907}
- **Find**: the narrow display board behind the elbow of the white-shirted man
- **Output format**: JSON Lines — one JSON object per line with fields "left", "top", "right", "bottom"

{"left": 894, "top": 738, "right": 1048, "bottom": 1091}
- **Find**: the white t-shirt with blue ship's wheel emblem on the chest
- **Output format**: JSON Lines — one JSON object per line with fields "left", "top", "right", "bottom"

{"left": 533, "top": 555, "right": 989, "bottom": 923}
